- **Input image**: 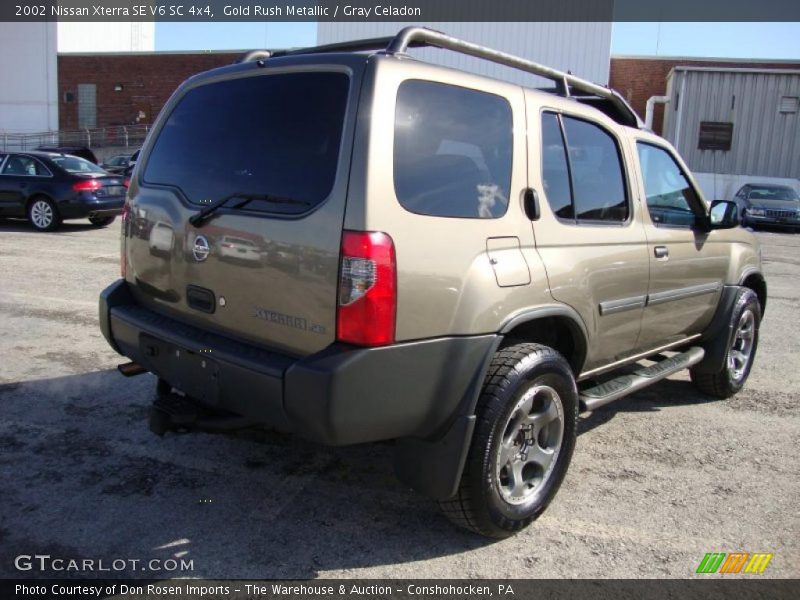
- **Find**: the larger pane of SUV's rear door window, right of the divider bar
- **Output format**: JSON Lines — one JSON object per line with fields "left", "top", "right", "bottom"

{"left": 562, "top": 117, "right": 628, "bottom": 222}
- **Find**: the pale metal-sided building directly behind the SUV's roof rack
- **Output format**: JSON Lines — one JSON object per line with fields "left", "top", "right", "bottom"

{"left": 317, "top": 22, "right": 611, "bottom": 87}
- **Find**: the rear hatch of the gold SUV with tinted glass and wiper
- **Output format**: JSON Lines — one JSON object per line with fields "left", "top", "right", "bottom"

{"left": 123, "top": 56, "right": 364, "bottom": 356}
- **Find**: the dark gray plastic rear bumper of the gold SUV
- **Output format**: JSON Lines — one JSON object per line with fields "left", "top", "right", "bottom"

{"left": 100, "top": 280, "right": 496, "bottom": 445}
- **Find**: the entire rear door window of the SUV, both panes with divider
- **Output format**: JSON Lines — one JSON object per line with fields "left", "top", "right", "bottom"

{"left": 542, "top": 113, "right": 629, "bottom": 223}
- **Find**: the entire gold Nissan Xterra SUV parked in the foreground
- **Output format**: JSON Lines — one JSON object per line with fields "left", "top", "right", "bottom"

{"left": 100, "top": 27, "right": 766, "bottom": 537}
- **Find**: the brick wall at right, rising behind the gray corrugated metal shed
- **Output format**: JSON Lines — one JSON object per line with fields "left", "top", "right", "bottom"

{"left": 609, "top": 57, "right": 800, "bottom": 134}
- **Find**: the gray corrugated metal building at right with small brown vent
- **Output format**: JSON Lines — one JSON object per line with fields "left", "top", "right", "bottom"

{"left": 664, "top": 67, "right": 800, "bottom": 179}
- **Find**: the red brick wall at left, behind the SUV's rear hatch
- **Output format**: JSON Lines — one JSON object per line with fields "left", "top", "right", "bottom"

{"left": 58, "top": 53, "right": 241, "bottom": 130}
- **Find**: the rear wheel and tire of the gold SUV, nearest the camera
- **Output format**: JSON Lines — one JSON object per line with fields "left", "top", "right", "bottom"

{"left": 439, "top": 343, "right": 578, "bottom": 538}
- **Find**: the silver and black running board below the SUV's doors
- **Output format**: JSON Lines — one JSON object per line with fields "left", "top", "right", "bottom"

{"left": 580, "top": 346, "right": 705, "bottom": 410}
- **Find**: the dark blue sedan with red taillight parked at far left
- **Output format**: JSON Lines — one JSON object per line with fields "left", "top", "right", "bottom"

{"left": 0, "top": 152, "right": 127, "bottom": 231}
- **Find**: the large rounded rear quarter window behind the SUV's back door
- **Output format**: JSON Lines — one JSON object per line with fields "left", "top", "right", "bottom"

{"left": 394, "top": 81, "right": 512, "bottom": 219}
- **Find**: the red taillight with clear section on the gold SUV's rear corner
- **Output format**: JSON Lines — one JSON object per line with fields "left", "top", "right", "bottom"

{"left": 336, "top": 231, "right": 397, "bottom": 346}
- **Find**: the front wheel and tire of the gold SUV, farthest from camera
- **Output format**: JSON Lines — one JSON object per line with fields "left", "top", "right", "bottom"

{"left": 690, "top": 288, "right": 761, "bottom": 400}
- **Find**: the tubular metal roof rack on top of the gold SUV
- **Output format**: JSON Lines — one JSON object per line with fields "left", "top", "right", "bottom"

{"left": 243, "top": 27, "right": 645, "bottom": 129}
